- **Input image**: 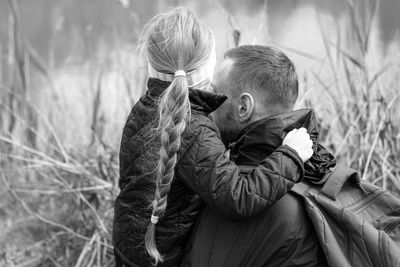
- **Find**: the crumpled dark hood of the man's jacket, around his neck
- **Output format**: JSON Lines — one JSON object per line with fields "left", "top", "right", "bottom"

{"left": 230, "top": 109, "right": 336, "bottom": 184}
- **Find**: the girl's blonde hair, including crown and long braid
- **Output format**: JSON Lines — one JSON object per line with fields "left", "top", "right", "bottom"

{"left": 141, "top": 8, "right": 215, "bottom": 265}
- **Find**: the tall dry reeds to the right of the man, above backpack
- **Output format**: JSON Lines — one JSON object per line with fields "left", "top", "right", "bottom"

{"left": 305, "top": 0, "right": 400, "bottom": 195}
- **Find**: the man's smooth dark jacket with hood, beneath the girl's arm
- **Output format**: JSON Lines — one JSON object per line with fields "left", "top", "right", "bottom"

{"left": 181, "top": 109, "right": 335, "bottom": 267}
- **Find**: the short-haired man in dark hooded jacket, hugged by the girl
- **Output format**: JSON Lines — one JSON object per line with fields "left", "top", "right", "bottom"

{"left": 182, "top": 46, "right": 335, "bottom": 267}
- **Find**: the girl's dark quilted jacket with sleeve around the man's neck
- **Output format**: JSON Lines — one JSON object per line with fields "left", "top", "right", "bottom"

{"left": 113, "top": 79, "right": 304, "bottom": 266}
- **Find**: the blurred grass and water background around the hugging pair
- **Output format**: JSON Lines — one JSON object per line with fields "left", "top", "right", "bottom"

{"left": 0, "top": 0, "right": 400, "bottom": 266}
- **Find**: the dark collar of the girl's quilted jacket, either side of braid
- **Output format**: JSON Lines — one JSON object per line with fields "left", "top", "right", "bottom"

{"left": 146, "top": 78, "right": 227, "bottom": 115}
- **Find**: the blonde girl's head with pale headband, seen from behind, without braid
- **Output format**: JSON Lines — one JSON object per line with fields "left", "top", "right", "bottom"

{"left": 140, "top": 8, "right": 216, "bottom": 89}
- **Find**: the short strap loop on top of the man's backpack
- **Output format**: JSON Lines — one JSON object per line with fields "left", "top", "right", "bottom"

{"left": 320, "top": 165, "right": 361, "bottom": 200}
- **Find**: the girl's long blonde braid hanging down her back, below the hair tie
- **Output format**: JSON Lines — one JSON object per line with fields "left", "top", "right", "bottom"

{"left": 145, "top": 76, "right": 190, "bottom": 265}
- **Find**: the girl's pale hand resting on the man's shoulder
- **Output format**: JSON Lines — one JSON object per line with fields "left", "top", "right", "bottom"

{"left": 282, "top": 127, "right": 314, "bottom": 162}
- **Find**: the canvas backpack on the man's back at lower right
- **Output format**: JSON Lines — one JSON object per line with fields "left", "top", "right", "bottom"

{"left": 292, "top": 166, "right": 400, "bottom": 267}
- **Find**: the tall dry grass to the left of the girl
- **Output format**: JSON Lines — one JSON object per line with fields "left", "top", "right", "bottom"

{"left": 0, "top": 0, "right": 137, "bottom": 266}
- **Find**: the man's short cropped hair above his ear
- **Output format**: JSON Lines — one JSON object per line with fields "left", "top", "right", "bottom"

{"left": 224, "top": 45, "right": 299, "bottom": 110}
